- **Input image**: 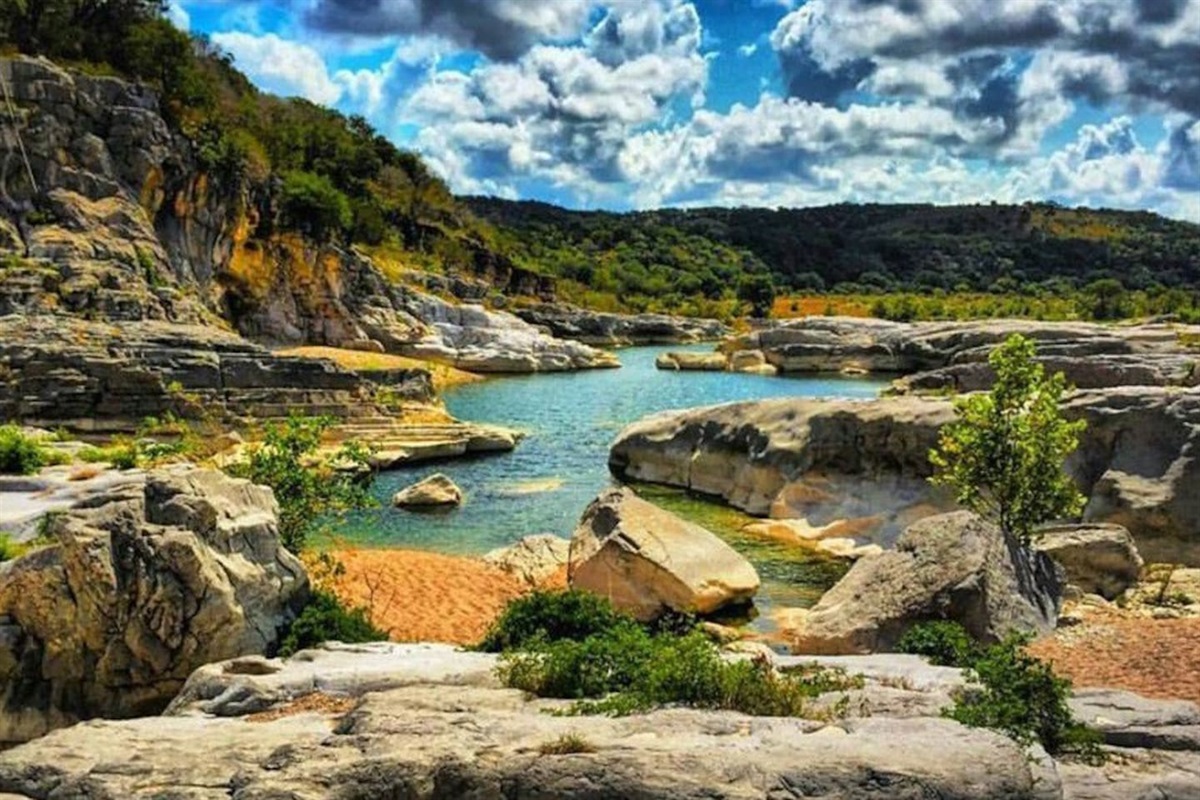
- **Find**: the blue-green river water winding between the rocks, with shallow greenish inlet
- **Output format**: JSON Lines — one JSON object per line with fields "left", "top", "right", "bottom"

{"left": 344, "top": 345, "right": 884, "bottom": 606}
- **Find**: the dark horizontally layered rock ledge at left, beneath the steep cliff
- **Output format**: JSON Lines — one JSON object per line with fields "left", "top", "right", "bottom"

{"left": 0, "top": 315, "right": 380, "bottom": 431}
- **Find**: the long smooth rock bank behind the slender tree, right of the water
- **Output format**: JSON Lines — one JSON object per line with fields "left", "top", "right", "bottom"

{"left": 610, "top": 386, "right": 1200, "bottom": 564}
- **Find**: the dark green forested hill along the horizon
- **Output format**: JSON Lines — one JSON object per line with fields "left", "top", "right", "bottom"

{"left": 466, "top": 198, "right": 1200, "bottom": 298}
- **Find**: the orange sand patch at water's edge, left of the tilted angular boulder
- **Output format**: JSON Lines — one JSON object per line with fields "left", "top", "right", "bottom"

{"left": 332, "top": 549, "right": 564, "bottom": 644}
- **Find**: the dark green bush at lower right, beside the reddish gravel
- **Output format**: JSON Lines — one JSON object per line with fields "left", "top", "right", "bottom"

{"left": 944, "top": 636, "right": 1104, "bottom": 762}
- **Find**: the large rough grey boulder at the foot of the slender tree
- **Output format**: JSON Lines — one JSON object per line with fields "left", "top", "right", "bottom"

{"left": 787, "top": 511, "right": 1062, "bottom": 655}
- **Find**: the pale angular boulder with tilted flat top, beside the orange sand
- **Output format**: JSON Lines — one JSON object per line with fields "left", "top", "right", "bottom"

{"left": 569, "top": 488, "right": 758, "bottom": 620}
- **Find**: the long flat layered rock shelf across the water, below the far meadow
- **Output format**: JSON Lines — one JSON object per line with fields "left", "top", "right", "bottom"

{"left": 721, "top": 317, "right": 1200, "bottom": 391}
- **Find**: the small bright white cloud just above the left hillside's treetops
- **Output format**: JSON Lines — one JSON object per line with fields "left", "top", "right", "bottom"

{"left": 212, "top": 31, "right": 342, "bottom": 106}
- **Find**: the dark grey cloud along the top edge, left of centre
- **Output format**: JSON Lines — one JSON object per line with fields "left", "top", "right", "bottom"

{"left": 298, "top": 0, "right": 593, "bottom": 60}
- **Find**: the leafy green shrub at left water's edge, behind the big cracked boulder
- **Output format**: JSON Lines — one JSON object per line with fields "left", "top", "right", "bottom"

{"left": 227, "top": 416, "right": 373, "bottom": 553}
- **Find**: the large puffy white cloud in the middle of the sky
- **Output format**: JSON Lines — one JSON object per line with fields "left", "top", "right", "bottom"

{"left": 401, "top": 0, "right": 708, "bottom": 193}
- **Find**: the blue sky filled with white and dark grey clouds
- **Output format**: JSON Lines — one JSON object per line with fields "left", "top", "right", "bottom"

{"left": 170, "top": 0, "right": 1200, "bottom": 222}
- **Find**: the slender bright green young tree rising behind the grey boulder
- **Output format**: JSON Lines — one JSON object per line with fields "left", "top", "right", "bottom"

{"left": 929, "top": 335, "right": 1086, "bottom": 543}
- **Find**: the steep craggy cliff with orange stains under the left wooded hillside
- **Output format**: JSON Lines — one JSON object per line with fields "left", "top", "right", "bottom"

{"left": 0, "top": 58, "right": 614, "bottom": 388}
